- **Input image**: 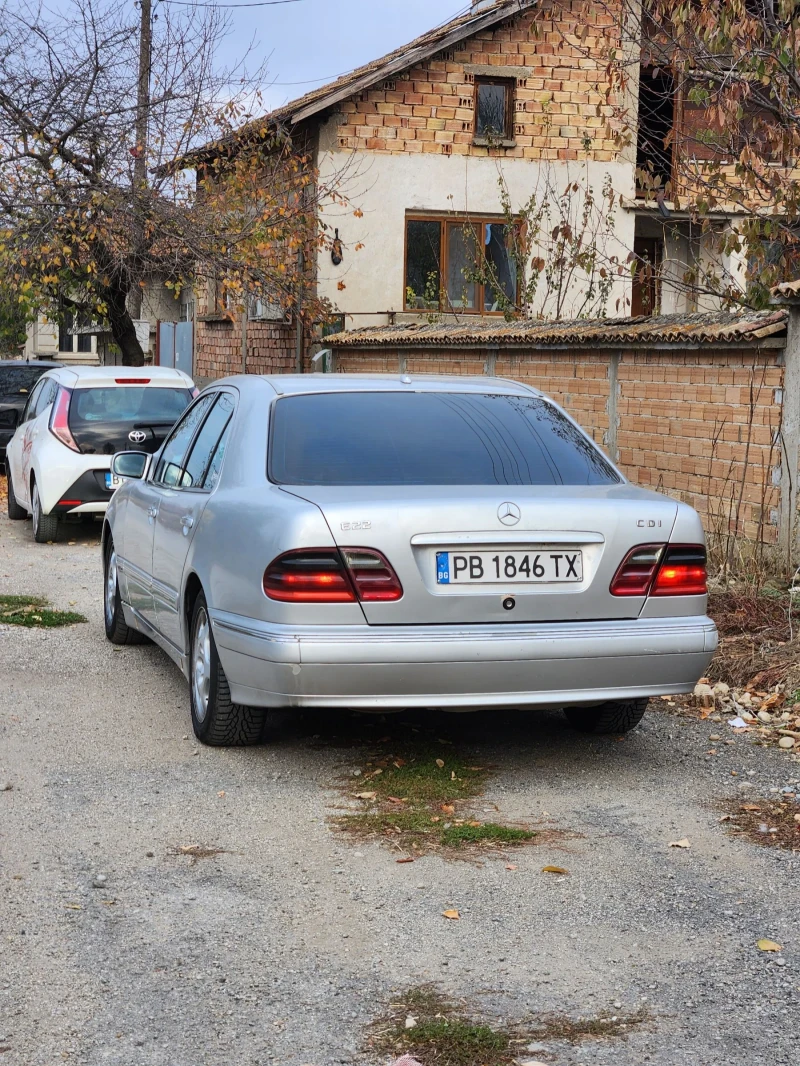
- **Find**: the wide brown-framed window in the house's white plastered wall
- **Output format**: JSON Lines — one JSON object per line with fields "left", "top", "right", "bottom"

{"left": 404, "top": 217, "right": 518, "bottom": 314}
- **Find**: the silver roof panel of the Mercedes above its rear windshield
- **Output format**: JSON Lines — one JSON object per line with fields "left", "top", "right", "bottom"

{"left": 213, "top": 373, "right": 544, "bottom": 395}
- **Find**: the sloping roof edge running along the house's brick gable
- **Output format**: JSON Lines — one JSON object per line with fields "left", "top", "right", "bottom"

{"left": 182, "top": 0, "right": 539, "bottom": 165}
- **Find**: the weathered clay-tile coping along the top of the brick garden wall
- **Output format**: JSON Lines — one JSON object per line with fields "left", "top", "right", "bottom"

{"left": 325, "top": 309, "right": 787, "bottom": 349}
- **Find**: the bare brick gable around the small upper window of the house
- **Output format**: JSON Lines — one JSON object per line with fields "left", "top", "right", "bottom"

{"left": 338, "top": 0, "right": 622, "bottom": 161}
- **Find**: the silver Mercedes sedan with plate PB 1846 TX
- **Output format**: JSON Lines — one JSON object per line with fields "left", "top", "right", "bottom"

{"left": 102, "top": 374, "right": 717, "bottom": 744}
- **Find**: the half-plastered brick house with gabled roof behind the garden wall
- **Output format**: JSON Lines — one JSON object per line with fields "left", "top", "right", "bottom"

{"left": 195, "top": 0, "right": 742, "bottom": 379}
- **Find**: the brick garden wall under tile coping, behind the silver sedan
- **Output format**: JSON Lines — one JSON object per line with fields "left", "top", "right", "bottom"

{"left": 336, "top": 348, "right": 783, "bottom": 544}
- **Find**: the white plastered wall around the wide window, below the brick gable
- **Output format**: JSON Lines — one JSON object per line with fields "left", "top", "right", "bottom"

{"left": 318, "top": 139, "right": 635, "bottom": 328}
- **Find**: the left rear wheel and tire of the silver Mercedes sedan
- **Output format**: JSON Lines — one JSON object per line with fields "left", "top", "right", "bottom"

{"left": 189, "top": 593, "right": 267, "bottom": 747}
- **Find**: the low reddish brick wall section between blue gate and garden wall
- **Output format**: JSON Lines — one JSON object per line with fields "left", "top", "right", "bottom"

{"left": 194, "top": 319, "right": 297, "bottom": 382}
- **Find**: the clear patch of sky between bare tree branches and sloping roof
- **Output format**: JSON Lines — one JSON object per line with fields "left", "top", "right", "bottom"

{"left": 203, "top": 0, "right": 469, "bottom": 108}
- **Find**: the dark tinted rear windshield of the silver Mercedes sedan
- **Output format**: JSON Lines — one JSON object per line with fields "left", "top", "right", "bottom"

{"left": 270, "top": 392, "right": 620, "bottom": 485}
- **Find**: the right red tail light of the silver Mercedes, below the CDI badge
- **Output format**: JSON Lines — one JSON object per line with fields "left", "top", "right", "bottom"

{"left": 610, "top": 544, "right": 708, "bottom": 596}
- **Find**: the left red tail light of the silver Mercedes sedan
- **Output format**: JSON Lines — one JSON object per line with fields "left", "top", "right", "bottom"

{"left": 263, "top": 548, "right": 403, "bottom": 603}
